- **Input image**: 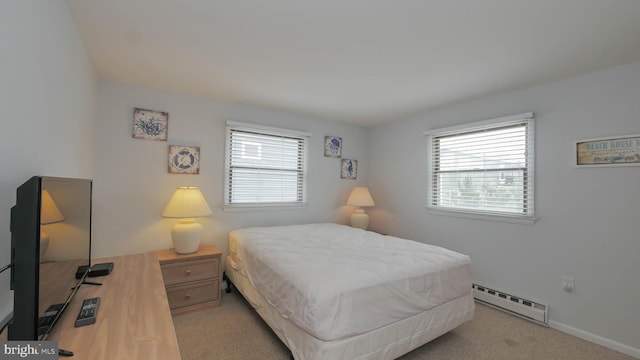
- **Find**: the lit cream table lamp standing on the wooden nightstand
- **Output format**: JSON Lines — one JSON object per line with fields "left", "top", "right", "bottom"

{"left": 162, "top": 186, "right": 212, "bottom": 254}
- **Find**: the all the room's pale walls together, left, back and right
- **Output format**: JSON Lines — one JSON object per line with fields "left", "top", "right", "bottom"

{"left": 0, "top": 0, "right": 640, "bottom": 357}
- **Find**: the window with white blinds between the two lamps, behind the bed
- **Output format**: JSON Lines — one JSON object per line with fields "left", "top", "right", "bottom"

{"left": 224, "top": 122, "right": 309, "bottom": 206}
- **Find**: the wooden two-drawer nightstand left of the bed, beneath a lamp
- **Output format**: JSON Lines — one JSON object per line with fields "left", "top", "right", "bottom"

{"left": 157, "top": 245, "right": 222, "bottom": 315}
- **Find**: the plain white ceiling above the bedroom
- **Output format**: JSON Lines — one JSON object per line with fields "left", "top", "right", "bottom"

{"left": 67, "top": 0, "right": 640, "bottom": 126}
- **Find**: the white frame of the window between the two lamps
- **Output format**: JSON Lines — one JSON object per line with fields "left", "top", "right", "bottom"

{"left": 223, "top": 121, "right": 311, "bottom": 211}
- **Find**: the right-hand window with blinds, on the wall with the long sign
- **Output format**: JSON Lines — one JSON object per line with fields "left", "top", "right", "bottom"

{"left": 426, "top": 113, "right": 535, "bottom": 220}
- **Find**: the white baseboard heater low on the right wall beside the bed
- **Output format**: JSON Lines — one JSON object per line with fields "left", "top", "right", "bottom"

{"left": 473, "top": 284, "right": 549, "bottom": 326}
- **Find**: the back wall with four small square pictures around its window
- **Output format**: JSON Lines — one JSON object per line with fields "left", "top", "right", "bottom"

{"left": 93, "top": 80, "right": 368, "bottom": 257}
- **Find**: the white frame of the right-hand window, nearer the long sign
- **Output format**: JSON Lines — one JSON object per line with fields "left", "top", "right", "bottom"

{"left": 424, "top": 112, "right": 537, "bottom": 223}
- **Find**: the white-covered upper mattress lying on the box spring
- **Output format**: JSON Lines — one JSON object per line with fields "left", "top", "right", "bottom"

{"left": 227, "top": 224, "right": 471, "bottom": 341}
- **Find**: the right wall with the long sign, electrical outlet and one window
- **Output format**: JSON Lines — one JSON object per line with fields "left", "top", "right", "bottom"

{"left": 368, "top": 63, "right": 640, "bottom": 356}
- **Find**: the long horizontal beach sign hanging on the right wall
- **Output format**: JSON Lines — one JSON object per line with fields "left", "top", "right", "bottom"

{"left": 575, "top": 135, "right": 640, "bottom": 167}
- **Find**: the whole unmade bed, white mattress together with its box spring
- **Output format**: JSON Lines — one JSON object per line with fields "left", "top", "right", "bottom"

{"left": 225, "top": 223, "right": 474, "bottom": 360}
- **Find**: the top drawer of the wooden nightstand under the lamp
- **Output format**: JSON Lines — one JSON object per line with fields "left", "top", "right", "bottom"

{"left": 161, "top": 258, "right": 220, "bottom": 286}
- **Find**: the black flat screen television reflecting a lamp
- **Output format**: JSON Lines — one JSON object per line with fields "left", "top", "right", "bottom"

{"left": 8, "top": 176, "right": 92, "bottom": 340}
